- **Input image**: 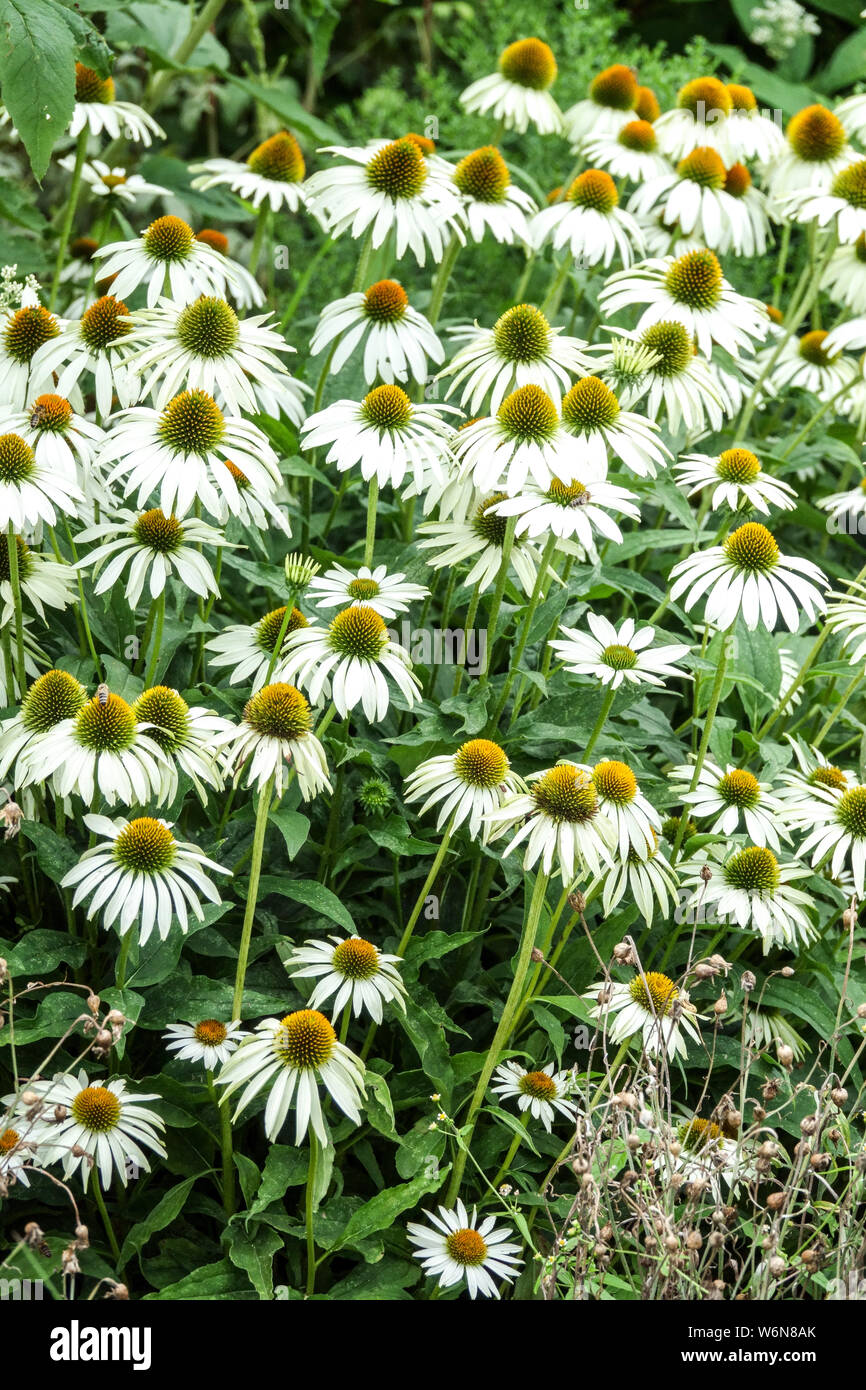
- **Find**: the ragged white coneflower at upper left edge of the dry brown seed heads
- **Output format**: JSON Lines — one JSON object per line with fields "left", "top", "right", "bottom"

{"left": 584, "top": 970, "right": 701, "bottom": 1056}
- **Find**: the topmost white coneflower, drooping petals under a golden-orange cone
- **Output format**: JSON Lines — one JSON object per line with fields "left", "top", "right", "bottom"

{"left": 460, "top": 39, "right": 563, "bottom": 135}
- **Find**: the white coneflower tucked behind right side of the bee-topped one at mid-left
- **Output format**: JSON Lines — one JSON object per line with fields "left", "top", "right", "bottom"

{"left": 132, "top": 685, "right": 236, "bottom": 805}
